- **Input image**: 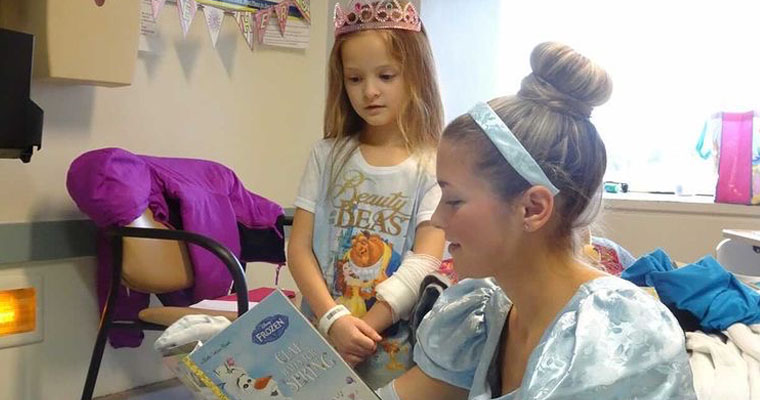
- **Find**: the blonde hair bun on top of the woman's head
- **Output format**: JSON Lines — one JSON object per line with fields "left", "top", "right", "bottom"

{"left": 517, "top": 42, "right": 612, "bottom": 118}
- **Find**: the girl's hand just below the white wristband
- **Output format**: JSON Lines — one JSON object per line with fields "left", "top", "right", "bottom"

{"left": 328, "top": 315, "right": 383, "bottom": 366}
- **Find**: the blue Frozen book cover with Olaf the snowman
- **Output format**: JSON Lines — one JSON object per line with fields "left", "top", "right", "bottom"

{"left": 183, "top": 290, "right": 379, "bottom": 400}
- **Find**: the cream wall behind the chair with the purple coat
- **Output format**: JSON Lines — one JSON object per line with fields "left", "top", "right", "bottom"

{"left": 0, "top": 0, "right": 328, "bottom": 400}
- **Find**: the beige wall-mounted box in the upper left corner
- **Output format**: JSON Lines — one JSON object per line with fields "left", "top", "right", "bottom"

{"left": 0, "top": 0, "right": 140, "bottom": 86}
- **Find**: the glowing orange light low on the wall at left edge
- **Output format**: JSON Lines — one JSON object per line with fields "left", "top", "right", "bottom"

{"left": 0, "top": 288, "right": 37, "bottom": 336}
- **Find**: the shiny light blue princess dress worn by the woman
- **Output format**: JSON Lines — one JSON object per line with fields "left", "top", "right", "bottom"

{"left": 414, "top": 277, "right": 697, "bottom": 400}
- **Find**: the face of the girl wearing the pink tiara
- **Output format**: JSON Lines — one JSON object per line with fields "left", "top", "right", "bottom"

{"left": 341, "top": 30, "right": 407, "bottom": 131}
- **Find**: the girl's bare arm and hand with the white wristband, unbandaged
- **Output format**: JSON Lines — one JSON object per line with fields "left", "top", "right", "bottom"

{"left": 288, "top": 208, "right": 382, "bottom": 364}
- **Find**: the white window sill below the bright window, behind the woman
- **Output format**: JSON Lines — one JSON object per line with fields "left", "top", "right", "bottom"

{"left": 604, "top": 193, "right": 760, "bottom": 218}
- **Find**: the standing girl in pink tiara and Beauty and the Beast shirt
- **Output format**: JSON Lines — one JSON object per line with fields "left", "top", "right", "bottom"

{"left": 288, "top": 0, "right": 444, "bottom": 387}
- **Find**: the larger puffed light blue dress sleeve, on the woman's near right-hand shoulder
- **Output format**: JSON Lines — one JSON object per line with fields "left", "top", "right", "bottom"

{"left": 521, "top": 278, "right": 696, "bottom": 400}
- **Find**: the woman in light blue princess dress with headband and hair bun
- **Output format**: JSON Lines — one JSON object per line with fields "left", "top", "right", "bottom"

{"left": 380, "top": 43, "right": 696, "bottom": 400}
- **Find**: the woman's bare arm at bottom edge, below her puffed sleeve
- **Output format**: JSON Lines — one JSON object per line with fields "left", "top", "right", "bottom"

{"left": 377, "top": 367, "right": 468, "bottom": 400}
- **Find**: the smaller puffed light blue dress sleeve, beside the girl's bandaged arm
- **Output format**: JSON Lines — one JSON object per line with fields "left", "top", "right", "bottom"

{"left": 414, "top": 279, "right": 510, "bottom": 389}
